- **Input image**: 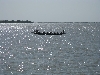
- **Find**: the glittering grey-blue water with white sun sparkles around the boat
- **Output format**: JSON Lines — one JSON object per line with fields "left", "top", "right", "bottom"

{"left": 0, "top": 23, "right": 100, "bottom": 75}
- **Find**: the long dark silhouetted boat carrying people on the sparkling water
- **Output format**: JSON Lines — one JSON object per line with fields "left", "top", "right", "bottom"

{"left": 31, "top": 30, "right": 66, "bottom": 35}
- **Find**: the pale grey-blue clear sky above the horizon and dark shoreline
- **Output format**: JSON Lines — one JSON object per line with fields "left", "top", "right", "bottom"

{"left": 0, "top": 0, "right": 100, "bottom": 22}
